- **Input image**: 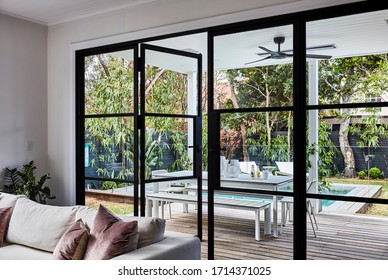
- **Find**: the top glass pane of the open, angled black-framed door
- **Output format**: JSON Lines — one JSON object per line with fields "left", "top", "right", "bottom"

{"left": 145, "top": 50, "right": 198, "bottom": 115}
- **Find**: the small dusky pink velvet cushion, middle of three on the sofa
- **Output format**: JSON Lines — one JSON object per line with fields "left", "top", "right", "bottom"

{"left": 53, "top": 219, "right": 89, "bottom": 260}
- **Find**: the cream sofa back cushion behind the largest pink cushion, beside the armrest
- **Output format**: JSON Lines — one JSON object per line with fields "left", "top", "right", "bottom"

{"left": 76, "top": 206, "right": 166, "bottom": 248}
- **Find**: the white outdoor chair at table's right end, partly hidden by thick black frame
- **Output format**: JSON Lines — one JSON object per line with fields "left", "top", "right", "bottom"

{"left": 280, "top": 180, "right": 318, "bottom": 237}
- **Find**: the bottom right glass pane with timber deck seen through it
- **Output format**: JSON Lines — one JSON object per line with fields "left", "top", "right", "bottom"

{"left": 307, "top": 201, "right": 388, "bottom": 260}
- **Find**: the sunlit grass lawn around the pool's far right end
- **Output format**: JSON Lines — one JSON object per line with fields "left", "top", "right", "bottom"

{"left": 328, "top": 178, "right": 388, "bottom": 216}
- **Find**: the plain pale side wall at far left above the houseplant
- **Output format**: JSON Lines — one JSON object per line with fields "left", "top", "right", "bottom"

{"left": 0, "top": 14, "right": 49, "bottom": 185}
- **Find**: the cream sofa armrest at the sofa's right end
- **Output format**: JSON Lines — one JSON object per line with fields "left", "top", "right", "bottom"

{"left": 113, "top": 236, "right": 201, "bottom": 260}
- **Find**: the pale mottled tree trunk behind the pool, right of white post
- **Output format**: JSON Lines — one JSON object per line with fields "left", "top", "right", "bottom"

{"left": 339, "top": 109, "right": 356, "bottom": 178}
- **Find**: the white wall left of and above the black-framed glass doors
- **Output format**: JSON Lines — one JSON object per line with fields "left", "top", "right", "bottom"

{"left": 48, "top": 0, "right": 360, "bottom": 204}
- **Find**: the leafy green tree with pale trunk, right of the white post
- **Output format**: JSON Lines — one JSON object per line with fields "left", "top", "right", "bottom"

{"left": 319, "top": 54, "right": 387, "bottom": 177}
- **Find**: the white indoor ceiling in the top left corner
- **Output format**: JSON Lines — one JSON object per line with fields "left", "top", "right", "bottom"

{"left": 0, "top": 0, "right": 160, "bottom": 25}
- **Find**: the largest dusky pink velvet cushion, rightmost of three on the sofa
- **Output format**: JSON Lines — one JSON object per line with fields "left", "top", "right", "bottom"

{"left": 84, "top": 205, "right": 138, "bottom": 260}
